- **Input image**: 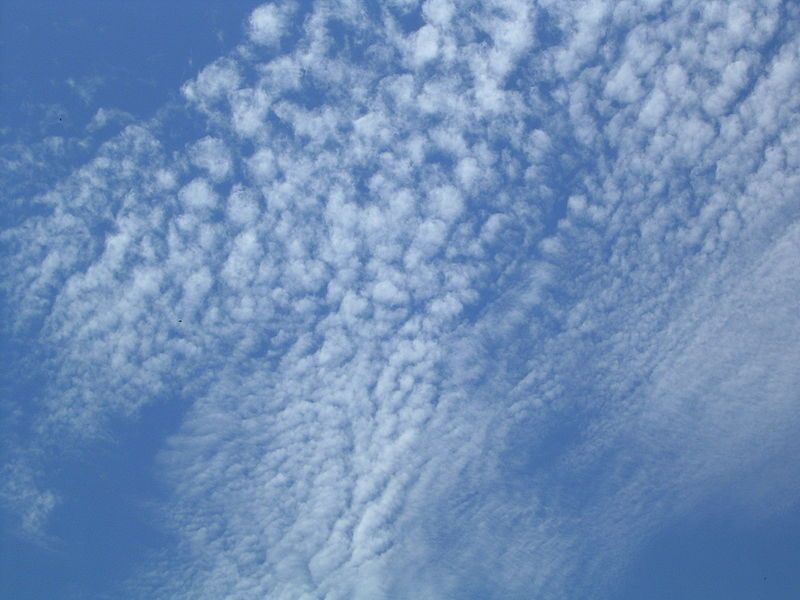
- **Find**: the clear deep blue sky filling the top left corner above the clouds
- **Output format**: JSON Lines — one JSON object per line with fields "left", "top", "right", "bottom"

{"left": 0, "top": 0, "right": 258, "bottom": 137}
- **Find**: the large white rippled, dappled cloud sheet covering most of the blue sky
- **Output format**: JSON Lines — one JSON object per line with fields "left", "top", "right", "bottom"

{"left": 3, "top": 0, "right": 800, "bottom": 598}
